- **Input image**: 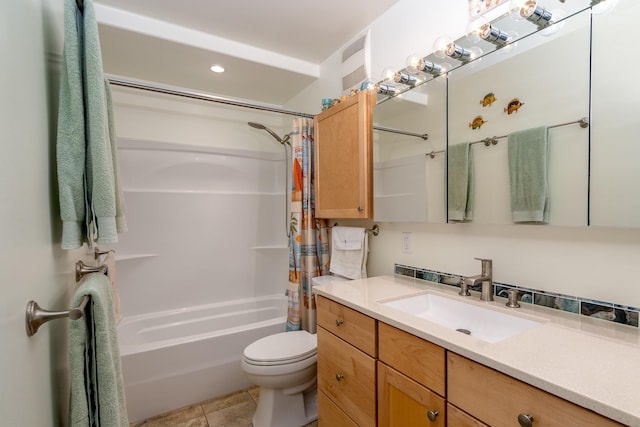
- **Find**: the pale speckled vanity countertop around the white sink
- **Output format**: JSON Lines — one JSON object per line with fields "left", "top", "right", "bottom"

{"left": 314, "top": 276, "right": 640, "bottom": 427}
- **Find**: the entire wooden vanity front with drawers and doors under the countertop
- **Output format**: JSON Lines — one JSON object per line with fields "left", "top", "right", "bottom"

{"left": 317, "top": 295, "right": 622, "bottom": 427}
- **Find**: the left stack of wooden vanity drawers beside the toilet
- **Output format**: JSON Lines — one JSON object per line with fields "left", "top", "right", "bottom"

{"left": 317, "top": 296, "right": 377, "bottom": 427}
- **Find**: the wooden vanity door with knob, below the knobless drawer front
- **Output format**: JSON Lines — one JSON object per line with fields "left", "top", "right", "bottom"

{"left": 378, "top": 362, "right": 446, "bottom": 427}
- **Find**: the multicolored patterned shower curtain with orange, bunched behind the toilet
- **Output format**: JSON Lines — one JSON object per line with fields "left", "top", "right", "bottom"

{"left": 286, "top": 117, "right": 329, "bottom": 333}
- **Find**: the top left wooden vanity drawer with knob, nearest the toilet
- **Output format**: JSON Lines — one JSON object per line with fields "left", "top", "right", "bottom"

{"left": 316, "top": 295, "right": 376, "bottom": 357}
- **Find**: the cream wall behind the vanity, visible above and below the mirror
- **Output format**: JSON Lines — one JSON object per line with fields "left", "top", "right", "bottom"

{"left": 291, "top": 0, "right": 640, "bottom": 307}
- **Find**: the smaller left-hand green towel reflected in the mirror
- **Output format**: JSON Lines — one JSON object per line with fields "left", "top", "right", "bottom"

{"left": 447, "top": 142, "right": 474, "bottom": 221}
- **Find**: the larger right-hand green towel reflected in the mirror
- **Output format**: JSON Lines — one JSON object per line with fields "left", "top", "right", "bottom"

{"left": 508, "top": 126, "right": 549, "bottom": 224}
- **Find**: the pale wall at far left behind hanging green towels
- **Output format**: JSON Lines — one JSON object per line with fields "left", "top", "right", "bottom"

{"left": 0, "top": 0, "right": 93, "bottom": 426}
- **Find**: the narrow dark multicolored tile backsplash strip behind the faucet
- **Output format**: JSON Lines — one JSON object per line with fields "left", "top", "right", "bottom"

{"left": 394, "top": 264, "right": 640, "bottom": 327}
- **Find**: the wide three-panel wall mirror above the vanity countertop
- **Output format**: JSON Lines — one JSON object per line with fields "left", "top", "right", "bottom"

{"left": 374, "top": 0, "right": 640, "bottom": 227}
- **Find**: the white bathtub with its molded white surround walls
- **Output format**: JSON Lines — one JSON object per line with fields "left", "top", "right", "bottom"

{"left": 110, "top": 138, "right": 288, "bottom": 420}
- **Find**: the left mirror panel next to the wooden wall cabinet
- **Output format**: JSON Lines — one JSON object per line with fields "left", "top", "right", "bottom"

{"left": 373, "top": 76, "right": 447, "bottom": 223}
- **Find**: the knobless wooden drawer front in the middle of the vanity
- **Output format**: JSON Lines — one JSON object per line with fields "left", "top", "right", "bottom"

{"left": 378, "top": 322, "right": 446, "bottom": 396}
